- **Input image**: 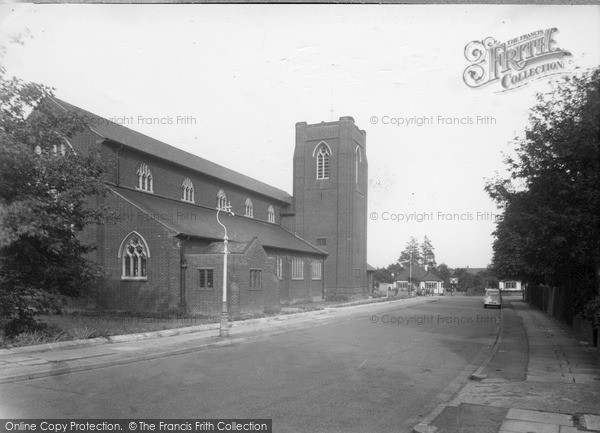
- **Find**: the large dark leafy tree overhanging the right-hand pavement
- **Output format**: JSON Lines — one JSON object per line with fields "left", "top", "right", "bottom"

{"left": 486, "top": 68, "right": 600, "bottom": 316}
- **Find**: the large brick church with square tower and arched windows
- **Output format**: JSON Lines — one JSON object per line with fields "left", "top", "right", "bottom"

{"left": 51, "top": 99, "right": 368, "bottom": 314}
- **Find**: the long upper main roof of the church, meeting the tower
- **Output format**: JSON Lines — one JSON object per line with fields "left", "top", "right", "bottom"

{"left": 50, "top": 98, "right": 292, "bottom": 204}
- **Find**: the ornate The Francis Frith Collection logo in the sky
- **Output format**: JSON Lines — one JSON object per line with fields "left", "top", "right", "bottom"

{"left": 463, "top": 27, "right": 571, "bottom": 91}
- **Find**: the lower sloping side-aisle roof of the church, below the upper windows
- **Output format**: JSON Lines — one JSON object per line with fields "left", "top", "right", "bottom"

{"left": 109, "top": 186, "right": 327, "bottom": 256}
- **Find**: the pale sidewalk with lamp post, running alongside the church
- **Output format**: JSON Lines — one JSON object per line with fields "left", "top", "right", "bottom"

{"left": 0, "top": 297, "right": 431, "bottom": 383}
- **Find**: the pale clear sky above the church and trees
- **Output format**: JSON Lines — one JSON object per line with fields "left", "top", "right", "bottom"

{"left": 0, "top": 4, "right": 600, "bottom": 268}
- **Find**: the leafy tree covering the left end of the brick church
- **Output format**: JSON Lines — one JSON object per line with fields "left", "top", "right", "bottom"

{"left": 0, "top": 62, "right": 109, "bottom": 336}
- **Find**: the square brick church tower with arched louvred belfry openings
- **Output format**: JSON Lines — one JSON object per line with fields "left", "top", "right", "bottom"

{"left": 294, "top": 117, "right": 368, "bottom": 295}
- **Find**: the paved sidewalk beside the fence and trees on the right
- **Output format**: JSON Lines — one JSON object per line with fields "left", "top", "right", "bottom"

{"left": 414, "top": 300, "right": 600, "bottom": 433}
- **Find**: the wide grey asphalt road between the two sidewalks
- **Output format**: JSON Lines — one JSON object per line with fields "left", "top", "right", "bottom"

{"left": 0, "top": 296, "right": 500, "bottom": 433}
